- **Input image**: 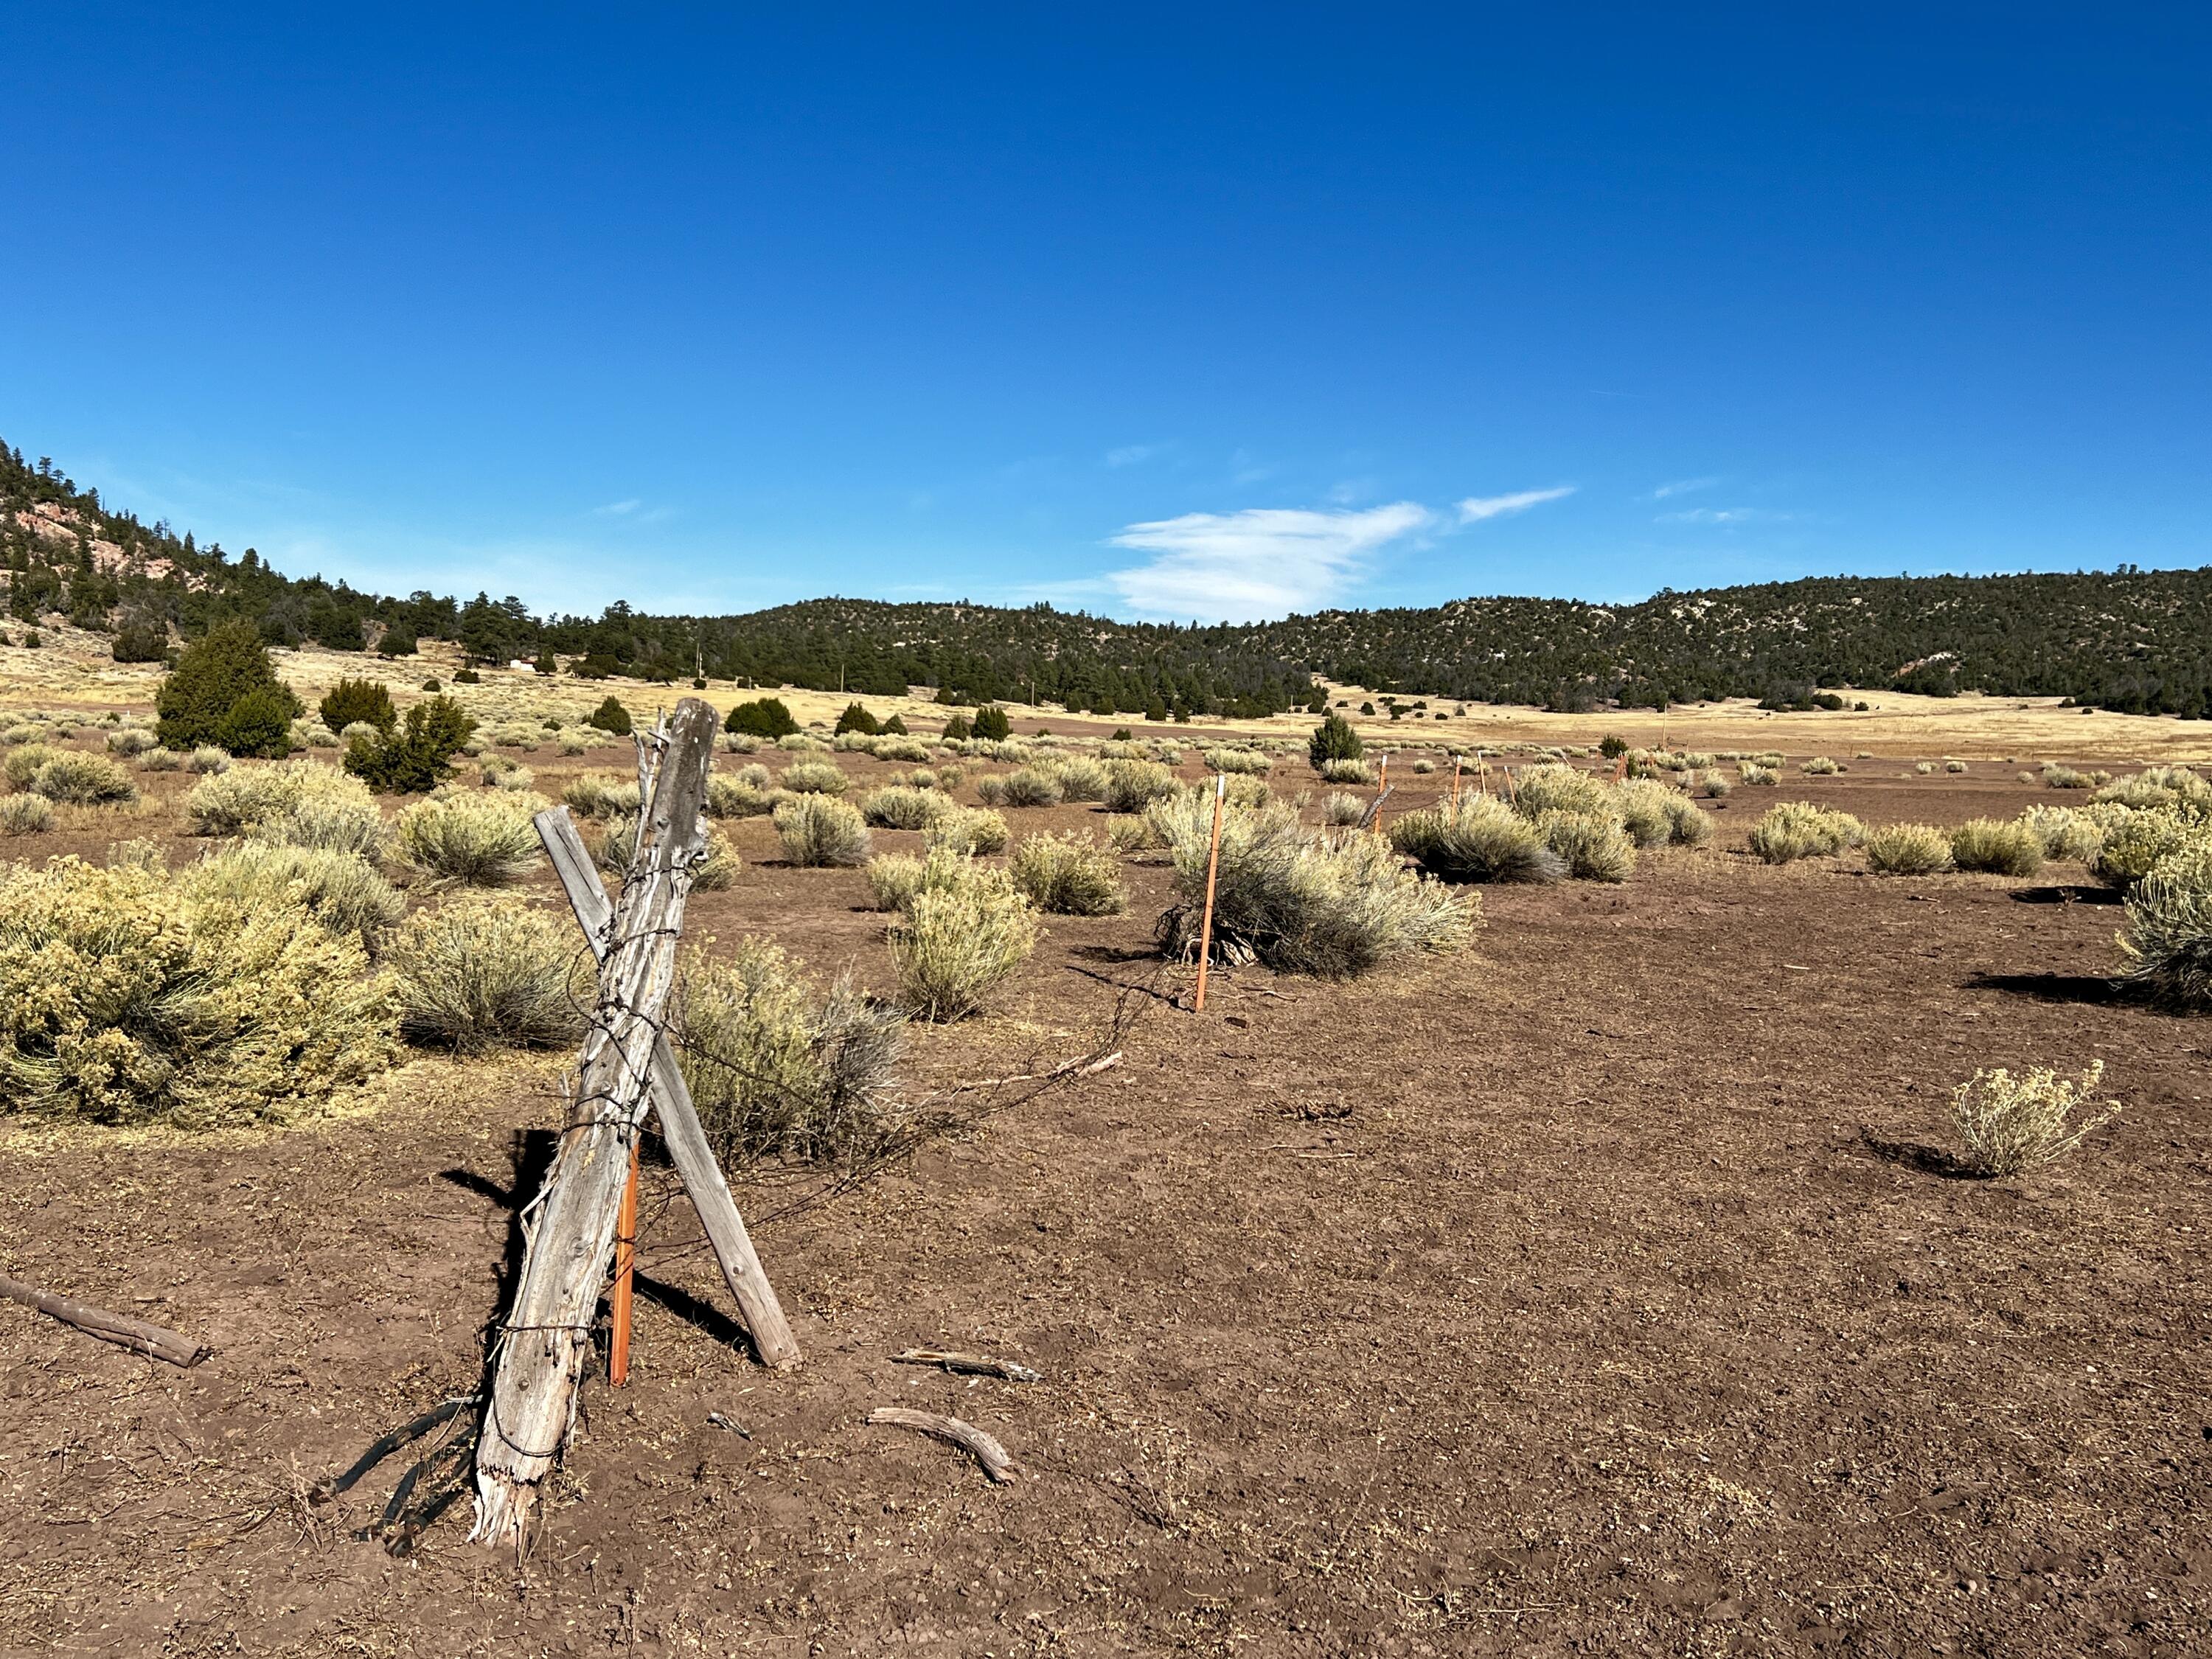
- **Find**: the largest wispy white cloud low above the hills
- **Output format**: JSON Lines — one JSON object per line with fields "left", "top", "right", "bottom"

{"left": 1106, "top": 502, "right": 1436, "bottom": 622}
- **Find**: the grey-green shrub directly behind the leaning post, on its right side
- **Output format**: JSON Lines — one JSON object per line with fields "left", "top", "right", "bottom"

{"left": 670, "top": 938, "right": 905, "bottom": 1168}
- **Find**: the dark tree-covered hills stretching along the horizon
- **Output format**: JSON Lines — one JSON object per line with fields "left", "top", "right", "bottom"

{"left": 0, "top": 445, "right": 2212, "bottom": 719}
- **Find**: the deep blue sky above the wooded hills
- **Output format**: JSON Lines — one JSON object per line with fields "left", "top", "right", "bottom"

{"left": 0, "top": 4, "right": 2212, "bottom": 619}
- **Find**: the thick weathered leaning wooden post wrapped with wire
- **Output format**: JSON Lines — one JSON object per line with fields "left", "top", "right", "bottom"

{"left": 469, "top": 697, "right": 714, "bottom": 1544}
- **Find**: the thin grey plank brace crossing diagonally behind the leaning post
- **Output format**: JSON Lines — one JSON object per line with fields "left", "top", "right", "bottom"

{"left": 535, "top": 807, "right": 799, "bottom": 1371}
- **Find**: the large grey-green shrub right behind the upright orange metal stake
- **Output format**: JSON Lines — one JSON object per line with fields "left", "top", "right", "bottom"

{"left": 1148, "top": 792, "right": 1480, "bottom": 980}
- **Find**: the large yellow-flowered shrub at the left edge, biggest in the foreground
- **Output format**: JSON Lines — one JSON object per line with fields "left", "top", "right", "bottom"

{"left": 0, "top": 858, "right": 394, "bottom": 1128}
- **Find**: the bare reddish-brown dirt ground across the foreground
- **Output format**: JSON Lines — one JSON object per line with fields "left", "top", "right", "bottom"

{"left": 0, "top": 699, "right": 2212, "bottom": 1657}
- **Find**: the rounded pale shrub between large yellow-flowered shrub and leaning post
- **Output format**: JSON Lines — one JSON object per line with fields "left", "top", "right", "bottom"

{"left": 385, "top": 894, "right": 597, "bottom": 1055}
